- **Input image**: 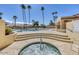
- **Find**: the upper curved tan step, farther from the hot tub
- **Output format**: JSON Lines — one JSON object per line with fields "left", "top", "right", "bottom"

{"left": 16, "top": 34, "right": 70, "bottom": 40}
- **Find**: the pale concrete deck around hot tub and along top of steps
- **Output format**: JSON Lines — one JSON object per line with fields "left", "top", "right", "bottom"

{"left": 0, "top": 30, "right": 77, "bottom": 55}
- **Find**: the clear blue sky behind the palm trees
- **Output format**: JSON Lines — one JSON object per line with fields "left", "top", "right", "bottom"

{"left": 0, "top": 4, "right": 79, "bottom": 24}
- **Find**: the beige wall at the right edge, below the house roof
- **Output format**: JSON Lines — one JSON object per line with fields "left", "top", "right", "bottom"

{"left": 66, "top": 20, "right": 79, "bottom": 54}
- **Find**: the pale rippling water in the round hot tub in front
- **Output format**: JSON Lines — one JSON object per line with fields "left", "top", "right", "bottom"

{"left": 19, "top": 43, "right": 61, "bottom": 55}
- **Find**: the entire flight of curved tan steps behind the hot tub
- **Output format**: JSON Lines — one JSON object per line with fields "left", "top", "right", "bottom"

{"left": 16, "top": 33, "right": 72, "bottom": 42}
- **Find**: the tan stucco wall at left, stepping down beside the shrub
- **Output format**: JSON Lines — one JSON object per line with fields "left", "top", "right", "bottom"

{"left": 0, "top": 20, "right": 15, "bottom": 49}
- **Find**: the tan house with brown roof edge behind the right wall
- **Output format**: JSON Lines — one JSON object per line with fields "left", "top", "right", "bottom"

{"left": 56, "top": 14, "right": 79, "bottom": 31}
